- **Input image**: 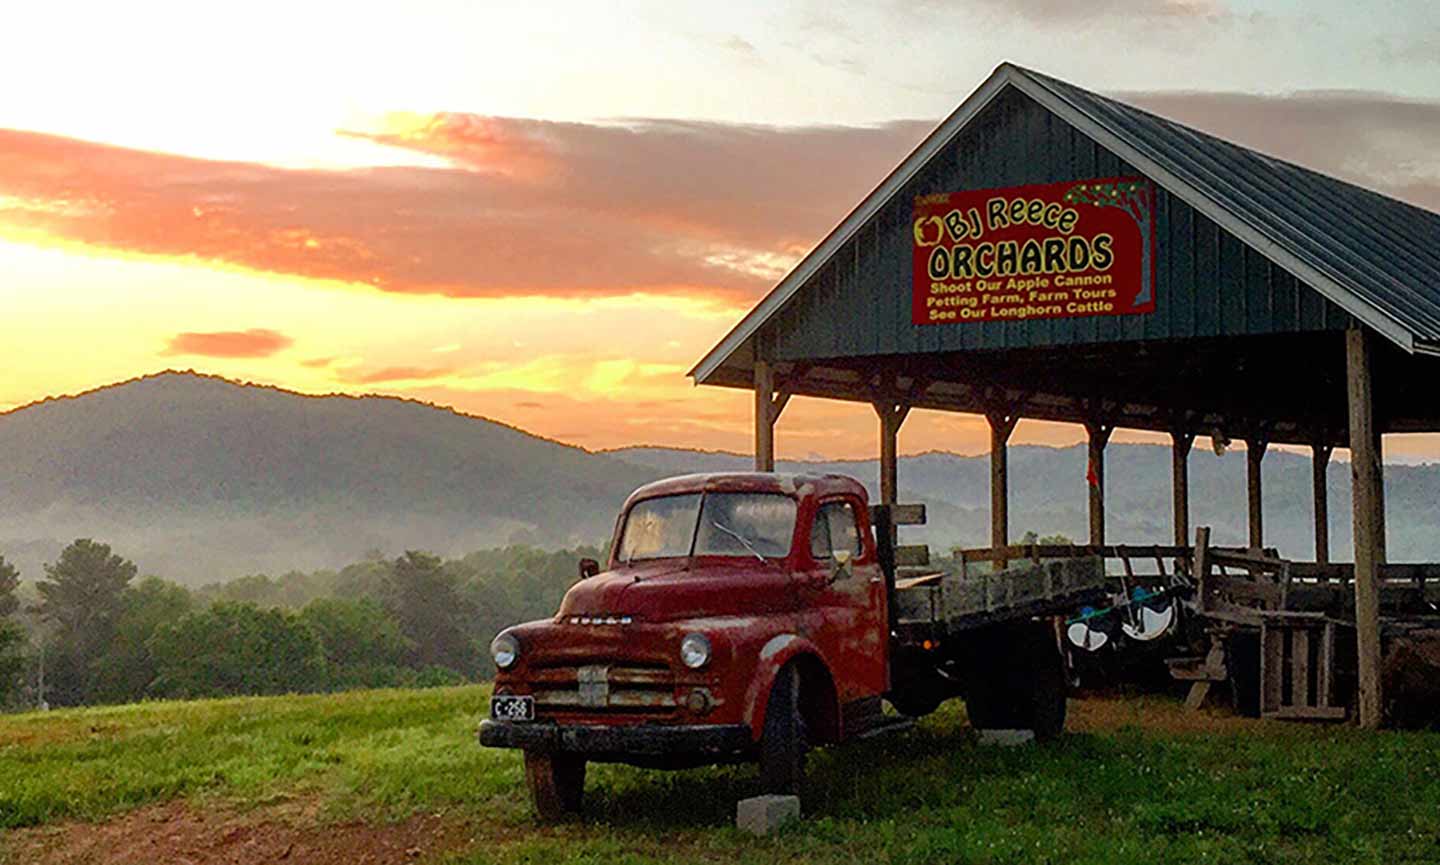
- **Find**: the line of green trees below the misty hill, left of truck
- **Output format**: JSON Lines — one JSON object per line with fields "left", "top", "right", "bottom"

{"left": 0, "top": 538, "right": 603, "bottom": 708}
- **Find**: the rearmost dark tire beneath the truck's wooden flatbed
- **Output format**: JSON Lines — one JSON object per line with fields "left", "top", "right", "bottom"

{"left": 965, "top": 628, "right": 1066, "bottom": 741}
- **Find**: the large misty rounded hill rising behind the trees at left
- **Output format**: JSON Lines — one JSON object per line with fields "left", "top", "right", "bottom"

{"left": 0, "top": 373, "right": 648, "bottom": 583}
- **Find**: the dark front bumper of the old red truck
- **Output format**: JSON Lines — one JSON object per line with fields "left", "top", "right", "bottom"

{"left": 480, "top": 721, "right": 753, "bottom": 763}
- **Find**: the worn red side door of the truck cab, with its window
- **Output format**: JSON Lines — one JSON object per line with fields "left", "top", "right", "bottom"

{"left": 801, "top": 497, "right": 890, "bottom": 704}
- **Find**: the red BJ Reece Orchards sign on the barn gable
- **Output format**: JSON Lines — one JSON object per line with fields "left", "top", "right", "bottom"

{"left": 912, "top": 177, "right": 1155, "bottom": 324}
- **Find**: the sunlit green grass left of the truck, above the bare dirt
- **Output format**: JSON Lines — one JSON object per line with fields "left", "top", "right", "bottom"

{"left": 0, "top": 687, "right": 520, "bottom": 828}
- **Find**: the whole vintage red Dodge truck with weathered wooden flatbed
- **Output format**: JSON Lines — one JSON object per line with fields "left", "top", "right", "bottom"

{"left": 480, "top": 474, "right": 1104, "bottom": 819}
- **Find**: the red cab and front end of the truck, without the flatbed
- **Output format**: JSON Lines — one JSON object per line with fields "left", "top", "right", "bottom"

{"left": 481, "top": 474, "right": 888, "bottom": 816}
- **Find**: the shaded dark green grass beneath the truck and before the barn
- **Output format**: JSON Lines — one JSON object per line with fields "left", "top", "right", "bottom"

{"left": 475, "top": 693, "right": 1440, "bottom": 865}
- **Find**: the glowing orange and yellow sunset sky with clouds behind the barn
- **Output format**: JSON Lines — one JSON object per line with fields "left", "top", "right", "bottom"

{"left": 0, "top": 0, "right": 1440, "bottom": 459}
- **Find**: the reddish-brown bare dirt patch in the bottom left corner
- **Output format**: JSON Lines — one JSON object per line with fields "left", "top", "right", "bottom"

{"left": 0, "top": 802, "right": 472, "bottom": 865}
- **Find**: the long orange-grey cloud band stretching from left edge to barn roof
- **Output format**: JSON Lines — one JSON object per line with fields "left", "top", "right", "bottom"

{"left": 0, "top": 115, "right": 926, "bottom": 304}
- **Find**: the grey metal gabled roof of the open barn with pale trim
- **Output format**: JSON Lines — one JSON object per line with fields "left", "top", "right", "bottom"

{"left": 690, "top": 63, "right": 1440, "bottom": 384}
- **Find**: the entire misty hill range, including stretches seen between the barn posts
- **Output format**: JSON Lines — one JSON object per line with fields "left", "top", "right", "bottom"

{"left": 0, "top": 373, "right": 1440, "bottom": 584}
